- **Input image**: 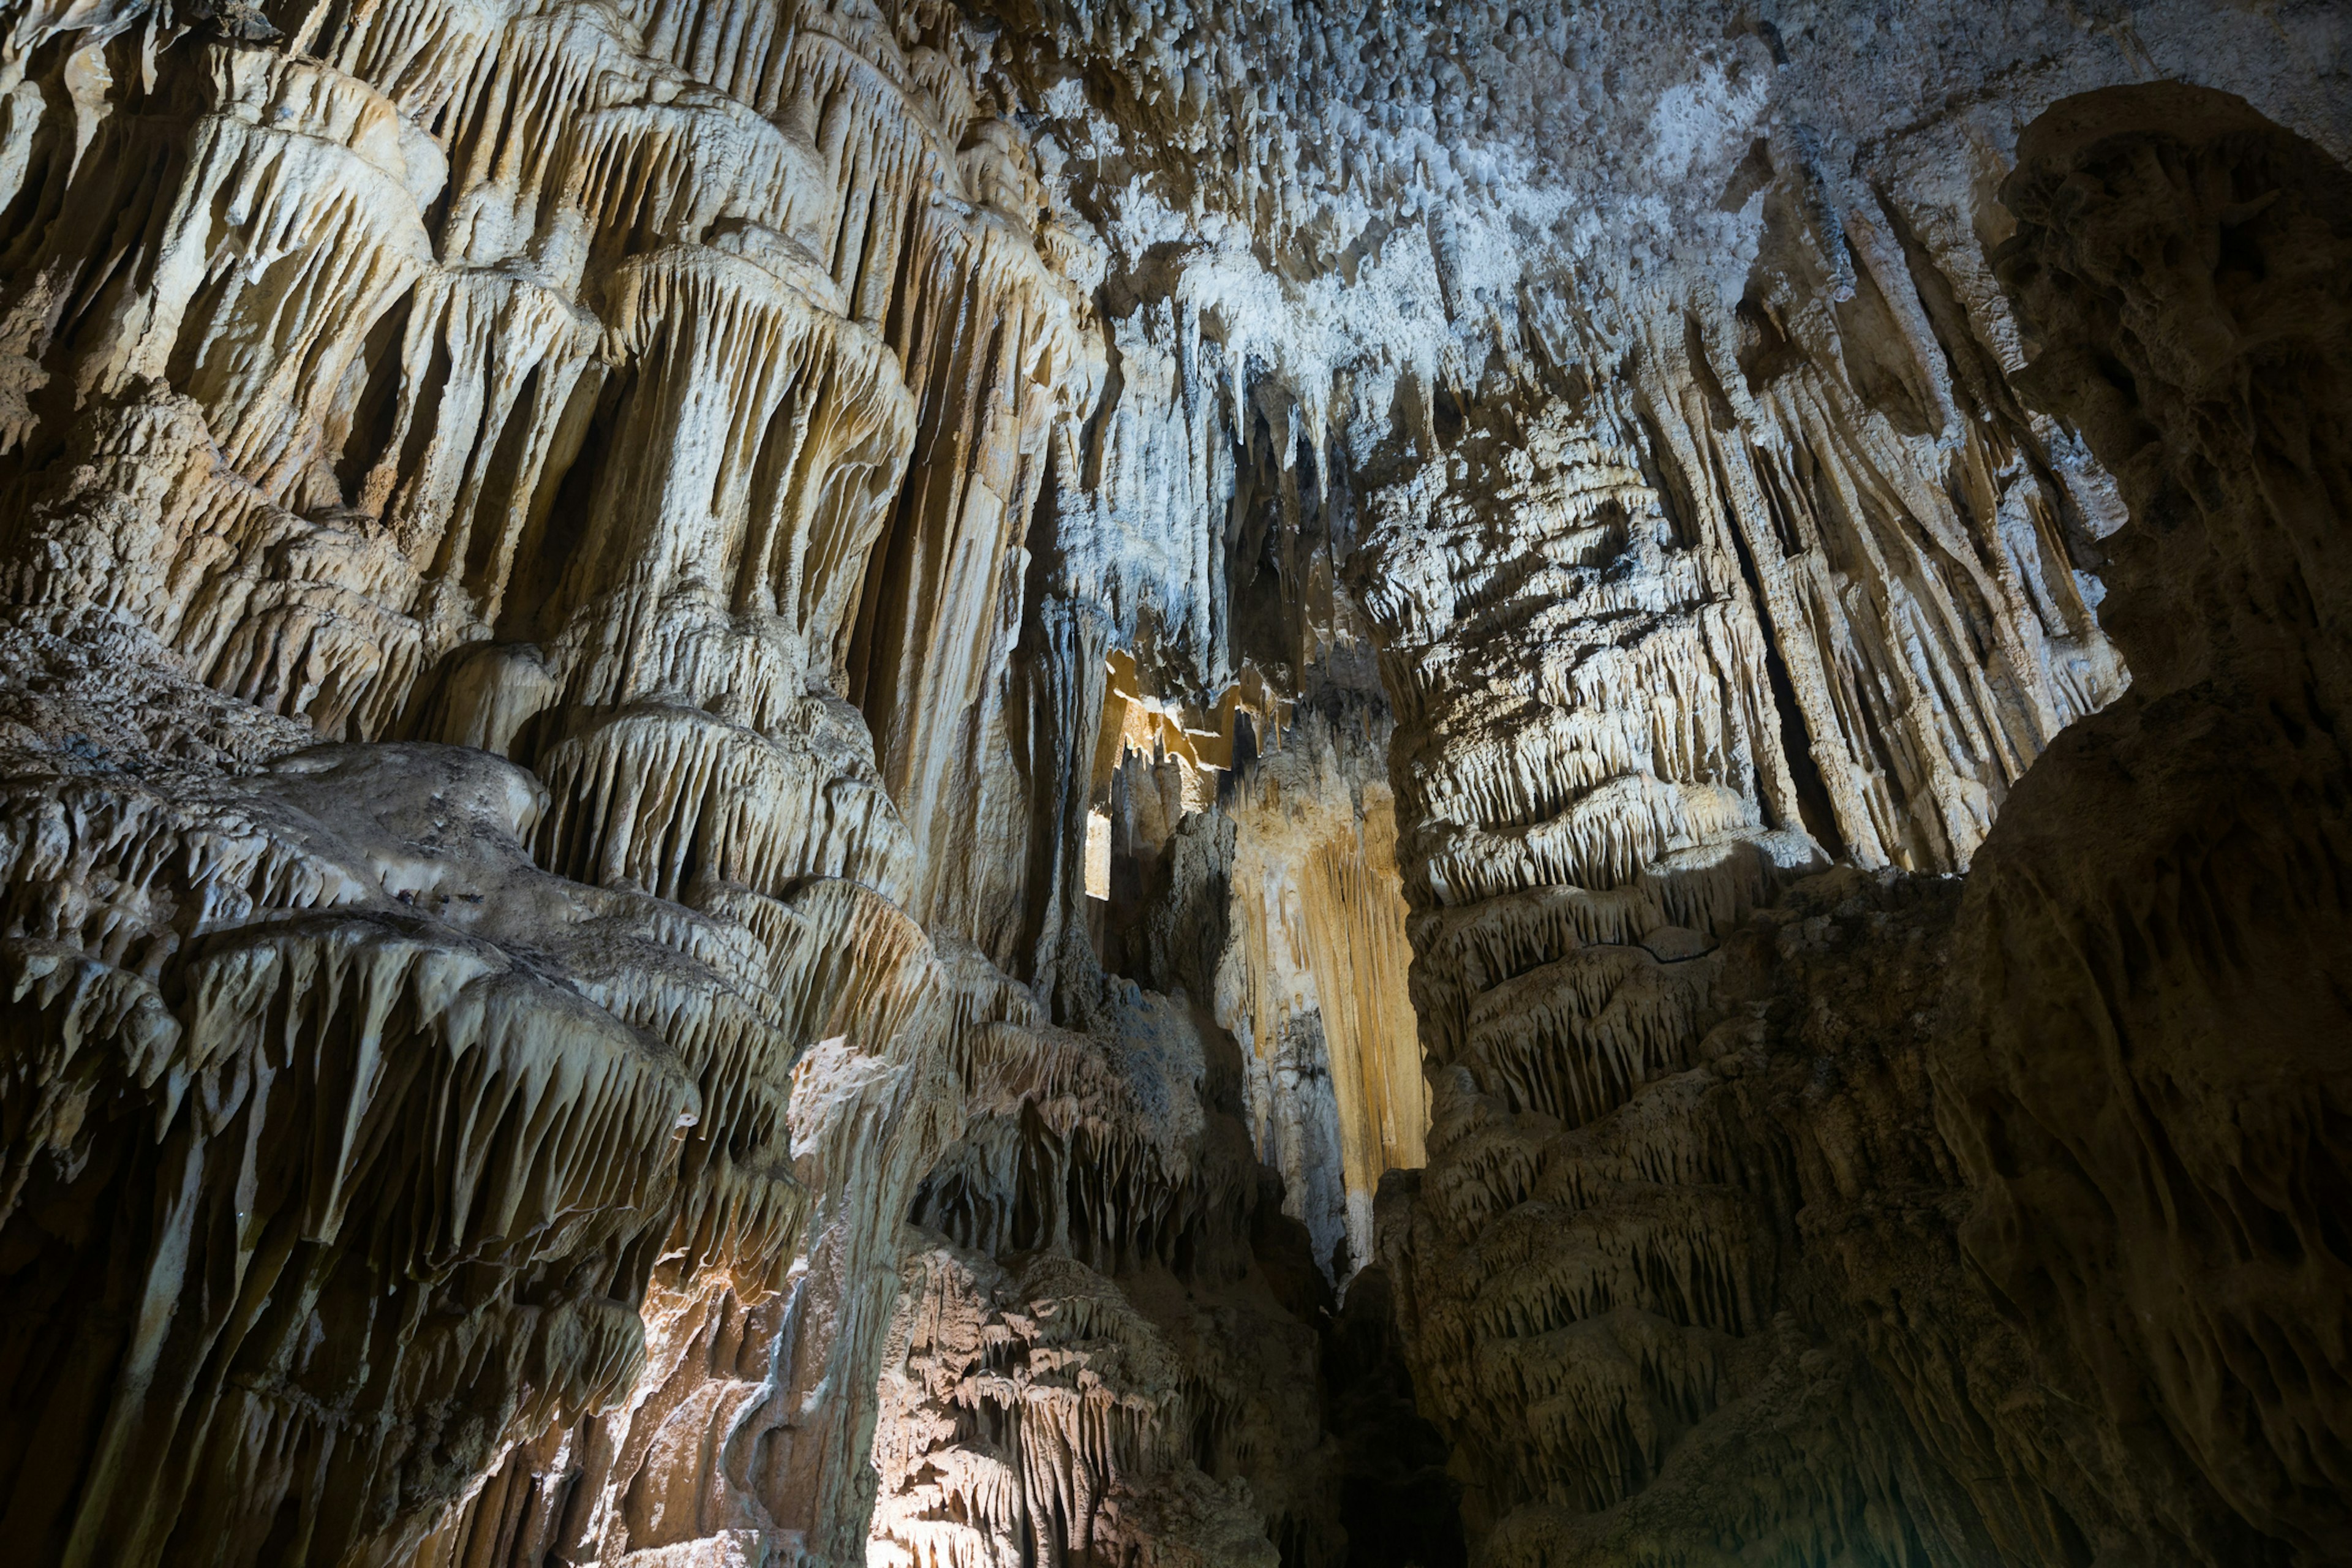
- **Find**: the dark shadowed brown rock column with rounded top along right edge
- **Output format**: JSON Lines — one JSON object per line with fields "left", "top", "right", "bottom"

{"left": 1936, "top": 87, "right": 2352, "bottom": 1561}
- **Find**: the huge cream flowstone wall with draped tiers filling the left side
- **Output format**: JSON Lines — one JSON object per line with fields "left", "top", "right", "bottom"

{"left": 5, "top": 5, "right": 1096, "bottom": 1563}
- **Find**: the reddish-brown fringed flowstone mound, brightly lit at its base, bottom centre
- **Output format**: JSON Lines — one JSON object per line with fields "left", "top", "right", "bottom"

{"left": 870, "top": 982, "right": 1345, "bottom": 1568}
